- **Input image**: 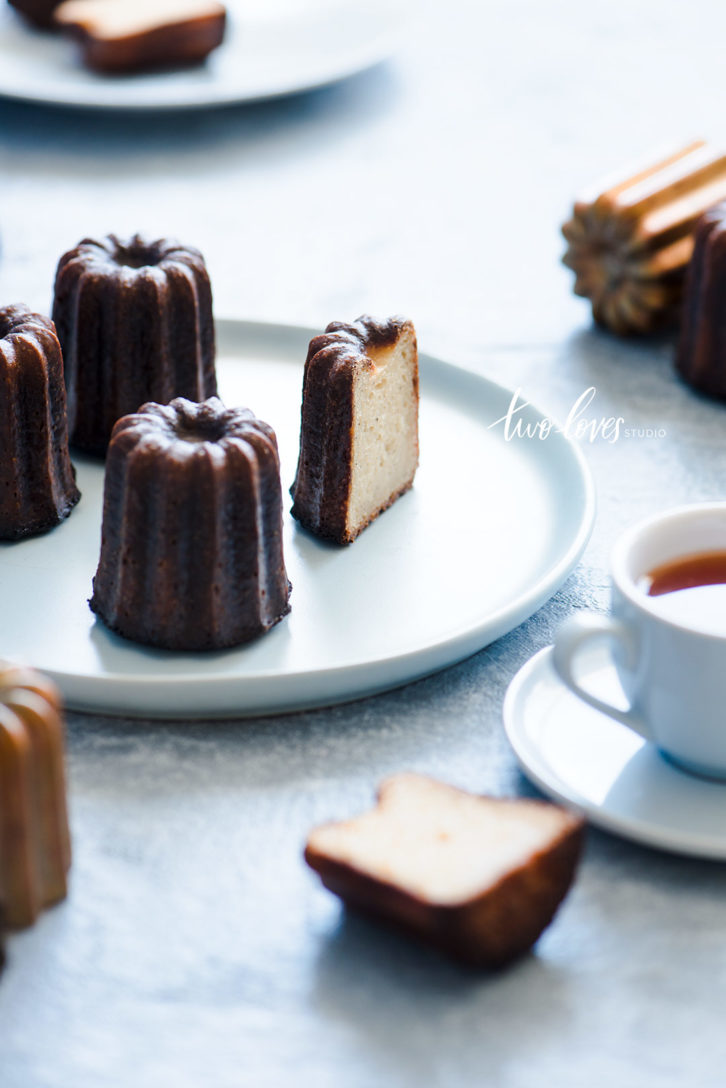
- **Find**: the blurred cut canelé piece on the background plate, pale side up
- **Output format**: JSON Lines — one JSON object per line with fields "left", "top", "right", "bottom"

{"left": 54, "top": 0, "right": 226, "bottom": 73}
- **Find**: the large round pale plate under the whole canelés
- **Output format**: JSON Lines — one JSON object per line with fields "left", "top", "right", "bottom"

{"left": 0, "top": 321, "right": 594, "bottom": 718}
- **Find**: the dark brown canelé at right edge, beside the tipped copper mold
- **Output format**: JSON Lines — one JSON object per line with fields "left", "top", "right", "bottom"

{"left": 676, "top": 202, "right": 726, "bottom": 399}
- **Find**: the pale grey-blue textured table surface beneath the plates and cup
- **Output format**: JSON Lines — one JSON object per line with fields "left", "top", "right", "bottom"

{"left": 0, "top": 0, "right": 726, "bottom": 1088}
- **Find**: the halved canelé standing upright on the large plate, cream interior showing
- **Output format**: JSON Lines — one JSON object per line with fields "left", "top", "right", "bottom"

{"left": 291, "top": 317, "right": 419, "bottom": 544}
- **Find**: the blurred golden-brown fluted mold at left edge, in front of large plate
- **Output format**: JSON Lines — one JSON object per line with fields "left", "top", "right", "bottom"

{"left": 0, "top": 663, "right": 71, "bottom": 929}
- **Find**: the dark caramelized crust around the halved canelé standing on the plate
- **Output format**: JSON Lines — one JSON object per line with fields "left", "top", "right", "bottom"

{"left": 291, "top": 316, "right": 419, "bottom": 544}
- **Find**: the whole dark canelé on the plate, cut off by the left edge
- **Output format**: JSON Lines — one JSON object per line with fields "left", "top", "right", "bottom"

{"left": 0, "top": 306, "right": 81, "bottom": 540}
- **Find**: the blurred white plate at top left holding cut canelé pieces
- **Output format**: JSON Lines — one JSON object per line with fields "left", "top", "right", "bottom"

{"left": 0, "top": 0, "right": 409, "bottom": 110}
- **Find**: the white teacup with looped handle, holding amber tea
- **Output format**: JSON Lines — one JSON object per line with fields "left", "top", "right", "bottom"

{"left": 554, "top": 503, "right": 726, "bottom": 779}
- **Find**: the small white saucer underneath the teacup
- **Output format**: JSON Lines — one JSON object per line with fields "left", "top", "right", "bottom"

{"left": 504, "top": 646, "right": 726, "bottom": 860}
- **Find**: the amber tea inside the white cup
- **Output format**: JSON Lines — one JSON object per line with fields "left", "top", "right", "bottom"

{"left": 638, "top": 551, "right": 726, "bottom": 635}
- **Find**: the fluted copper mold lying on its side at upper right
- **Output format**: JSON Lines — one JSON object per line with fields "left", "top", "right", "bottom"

{"left": 563, "top": 140, "right": 726, "bottom": 335}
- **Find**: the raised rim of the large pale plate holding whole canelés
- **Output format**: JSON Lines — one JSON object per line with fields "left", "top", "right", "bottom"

{"left": 4, "top": 317, "right": 595, "bottom": 720}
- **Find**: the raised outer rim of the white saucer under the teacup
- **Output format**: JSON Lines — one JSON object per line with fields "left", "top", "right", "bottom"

{"left": 502, "top": 645, "right": 726, "bottom": 862}
